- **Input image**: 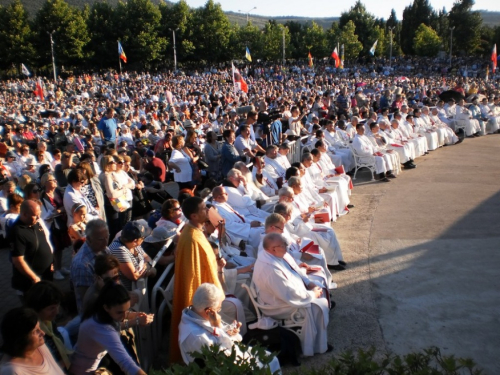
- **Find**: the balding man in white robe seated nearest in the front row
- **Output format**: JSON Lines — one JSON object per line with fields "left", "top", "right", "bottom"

{"left": 253, "top": 233, "right": 333, "bottom": 356}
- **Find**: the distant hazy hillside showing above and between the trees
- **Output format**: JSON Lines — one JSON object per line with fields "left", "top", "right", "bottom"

{"left": 0, "top": 0, "right": 500, "bottom": 29}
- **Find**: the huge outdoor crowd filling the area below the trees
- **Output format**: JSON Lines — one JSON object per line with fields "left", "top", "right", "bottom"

{"left": 0, "top": 59, "right": 500, "bottom": 375}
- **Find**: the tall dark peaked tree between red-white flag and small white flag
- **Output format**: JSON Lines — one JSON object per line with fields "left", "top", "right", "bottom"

{"left": 339, "top": 0, "right": 375, "bottom": 54}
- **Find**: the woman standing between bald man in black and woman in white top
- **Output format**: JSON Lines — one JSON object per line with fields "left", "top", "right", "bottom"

{"left": 40, "top": 173, "right": 71, "bottom": 280}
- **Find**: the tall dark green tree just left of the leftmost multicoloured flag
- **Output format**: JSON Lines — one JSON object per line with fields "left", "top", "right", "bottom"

{"left": 87, "top": 1, "right": 119, "bottom": 69}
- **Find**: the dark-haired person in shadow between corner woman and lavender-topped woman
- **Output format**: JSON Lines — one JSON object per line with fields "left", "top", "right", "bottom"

{"left": 24, "top": 281, "right": 72, "bottom": 370}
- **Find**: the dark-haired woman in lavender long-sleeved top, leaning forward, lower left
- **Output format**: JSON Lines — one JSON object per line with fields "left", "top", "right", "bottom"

{"left": 69, "top": 280, "right": 153, "bottom": 375}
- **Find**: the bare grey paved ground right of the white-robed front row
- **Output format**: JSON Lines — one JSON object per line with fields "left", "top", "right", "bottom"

{"left": 296, "top": 135, "right": 500, "bottom": 374}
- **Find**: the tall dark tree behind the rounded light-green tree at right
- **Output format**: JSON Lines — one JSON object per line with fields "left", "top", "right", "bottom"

{"left": 401, "top": 0, "right": 435, "bottom": 55}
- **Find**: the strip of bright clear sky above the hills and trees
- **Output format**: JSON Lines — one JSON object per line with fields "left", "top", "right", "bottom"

{"left": 178, "top": 0, "right": 500, "bottom": 20}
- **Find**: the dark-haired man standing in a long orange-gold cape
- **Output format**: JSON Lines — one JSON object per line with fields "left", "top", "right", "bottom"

{"left": 170, "top": 197, "right": 222, "bottom": 364}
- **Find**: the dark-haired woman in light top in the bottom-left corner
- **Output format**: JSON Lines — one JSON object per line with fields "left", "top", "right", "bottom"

{"left": 0, "top": 307, "right": 64, "bottom": 375}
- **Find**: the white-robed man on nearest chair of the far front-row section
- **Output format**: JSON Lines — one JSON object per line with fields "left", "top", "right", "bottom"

{"left": 352, "top": 124, "right": 396, "bottom": 182}
